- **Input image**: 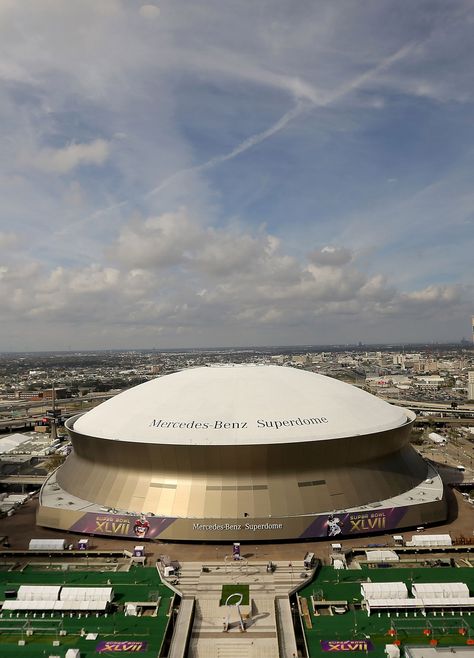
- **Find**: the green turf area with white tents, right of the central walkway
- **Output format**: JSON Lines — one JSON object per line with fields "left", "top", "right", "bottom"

{"left": 300, "top": 567, "right": 474, "bottom": 658}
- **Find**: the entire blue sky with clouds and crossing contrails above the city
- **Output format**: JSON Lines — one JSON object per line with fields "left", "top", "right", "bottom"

{"left": 0, "top": 0, "right": 474, "bottom": 351}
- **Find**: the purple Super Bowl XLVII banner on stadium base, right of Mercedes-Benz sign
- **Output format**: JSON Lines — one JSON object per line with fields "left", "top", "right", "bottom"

{"left": 301, "top": 507, "right": 407, "bottom": 538}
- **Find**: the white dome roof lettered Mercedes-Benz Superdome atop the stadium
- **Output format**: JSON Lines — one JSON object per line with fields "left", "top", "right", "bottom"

{"left": 73, "top": 365, "right": 413, "bottom": 445}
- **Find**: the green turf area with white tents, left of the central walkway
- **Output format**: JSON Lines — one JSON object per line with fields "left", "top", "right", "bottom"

{"left": 0, "top": 567, "right": 172, "bottom": 658}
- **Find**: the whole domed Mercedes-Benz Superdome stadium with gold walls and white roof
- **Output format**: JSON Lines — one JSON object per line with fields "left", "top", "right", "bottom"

{"left": 37, "top": 365, "right": 447, "bottom": 541}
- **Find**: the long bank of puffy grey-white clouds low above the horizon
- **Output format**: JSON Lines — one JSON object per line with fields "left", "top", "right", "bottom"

{"left": 0, "top": 208, "right": 465, "bottom": 344}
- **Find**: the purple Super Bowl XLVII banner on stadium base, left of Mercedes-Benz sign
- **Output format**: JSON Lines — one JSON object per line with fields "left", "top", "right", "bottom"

{"left": 69, "top": 512, "right": 175, "bottom": 539}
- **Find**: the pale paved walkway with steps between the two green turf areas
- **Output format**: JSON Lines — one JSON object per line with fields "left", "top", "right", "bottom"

{"left": 167, "top": 560, "right": 306, "bottom": 658}
